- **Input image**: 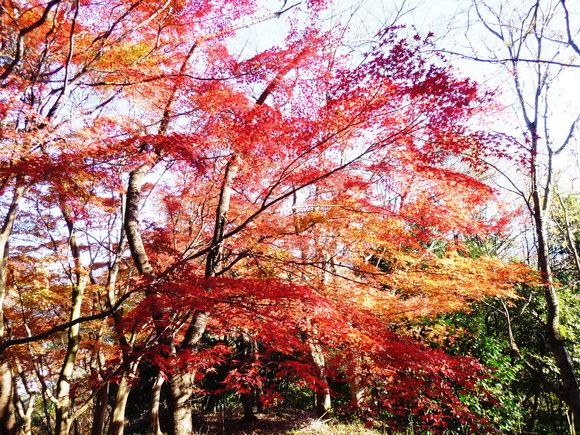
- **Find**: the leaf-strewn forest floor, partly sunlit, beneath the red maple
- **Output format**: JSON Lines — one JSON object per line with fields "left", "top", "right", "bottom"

{"left": 191, "top": 408, "right": 382, "bottom": 435}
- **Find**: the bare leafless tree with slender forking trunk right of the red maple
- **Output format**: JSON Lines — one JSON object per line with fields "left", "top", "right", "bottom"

{"left": 473, "top": 4, "right": 580, "bottom": 424}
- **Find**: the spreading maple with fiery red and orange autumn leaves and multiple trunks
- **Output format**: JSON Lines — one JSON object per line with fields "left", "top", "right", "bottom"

{"left": 0, "top": 0, "right": 536, "bottom": 434}
